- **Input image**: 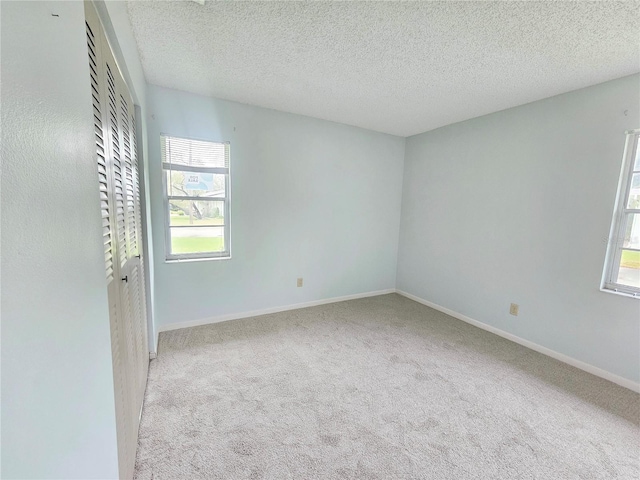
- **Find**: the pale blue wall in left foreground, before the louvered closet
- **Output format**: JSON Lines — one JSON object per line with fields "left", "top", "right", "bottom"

{"left": 1, "top": 2, "right": 118, "bottom": 479}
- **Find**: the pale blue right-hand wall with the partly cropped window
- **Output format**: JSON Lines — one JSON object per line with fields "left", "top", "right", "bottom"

{"left": 398, "top": 75, "right": 640, "bottom": 382}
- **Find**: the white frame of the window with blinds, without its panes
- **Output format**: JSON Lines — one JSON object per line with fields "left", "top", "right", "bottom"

{"left": 160, "top": 133, "right": 231, "bottom": 263}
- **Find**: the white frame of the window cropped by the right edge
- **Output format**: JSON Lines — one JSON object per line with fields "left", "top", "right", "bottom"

{"left": 600, "top": 129, "right": 640, "bottom": 299}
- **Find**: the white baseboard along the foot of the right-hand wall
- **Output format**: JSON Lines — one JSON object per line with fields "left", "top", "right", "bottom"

{"left": 396, "top": 290, "right": 640, "bottom": 393}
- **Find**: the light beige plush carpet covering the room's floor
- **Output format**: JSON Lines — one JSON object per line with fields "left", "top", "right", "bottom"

{"left": 136, "top": 294, "right": 640, "bottom": 480}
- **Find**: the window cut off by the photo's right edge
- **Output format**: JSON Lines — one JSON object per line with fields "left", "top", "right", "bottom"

{"left": 602, "top": 129, "right": 640, "bottom": 298}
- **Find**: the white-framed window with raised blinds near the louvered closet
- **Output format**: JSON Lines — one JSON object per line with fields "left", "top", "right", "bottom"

{"left": 160, "top": 135, "right": 231, "bottom": 261}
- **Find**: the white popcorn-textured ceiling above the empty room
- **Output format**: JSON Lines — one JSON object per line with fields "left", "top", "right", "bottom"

{"left": 128, "top": 0, "right": 640, "bottom": 136}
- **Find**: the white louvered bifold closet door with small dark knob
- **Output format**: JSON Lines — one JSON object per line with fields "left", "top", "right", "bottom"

{"left": 85, "top": 2, "right": 149, "bottom": 479}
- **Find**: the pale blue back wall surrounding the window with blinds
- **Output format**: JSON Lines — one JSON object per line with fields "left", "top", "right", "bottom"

{"left": 148, "top": 86, "right": 405, "bottom": 327}
